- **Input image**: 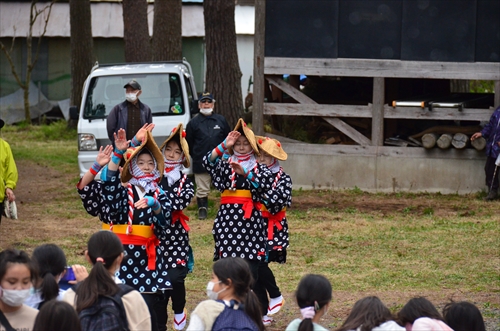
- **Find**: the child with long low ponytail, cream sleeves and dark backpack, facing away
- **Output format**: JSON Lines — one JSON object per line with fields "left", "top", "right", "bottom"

{"left": 63, "top": 231, "right": 151, "bottom": 330}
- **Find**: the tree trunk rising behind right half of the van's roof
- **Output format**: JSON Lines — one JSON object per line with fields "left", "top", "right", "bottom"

{"left": 151, "top": 0, "right": 182, "bottom": 61}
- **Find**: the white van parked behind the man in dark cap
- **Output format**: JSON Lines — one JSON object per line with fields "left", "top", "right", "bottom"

{"left": 70, "top": 61, "right": 198, "bottom": 176}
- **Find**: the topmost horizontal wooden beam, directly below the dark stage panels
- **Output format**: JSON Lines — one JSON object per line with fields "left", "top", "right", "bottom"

{"left": 264, "top": 57, "right": 500, "bottom": 80}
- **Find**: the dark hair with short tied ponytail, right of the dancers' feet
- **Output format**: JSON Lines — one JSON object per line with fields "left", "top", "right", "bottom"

{"left": 295, "top": 274, "right": 332, "bottom": 331}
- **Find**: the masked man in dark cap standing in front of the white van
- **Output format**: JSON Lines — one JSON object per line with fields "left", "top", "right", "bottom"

{"left": 106, "top": 79, "right": 153, "bottom": 146}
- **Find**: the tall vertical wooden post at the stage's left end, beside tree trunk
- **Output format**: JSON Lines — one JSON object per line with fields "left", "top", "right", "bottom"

{"left": 252, "top": 0, "right": 266, "bottom": 135}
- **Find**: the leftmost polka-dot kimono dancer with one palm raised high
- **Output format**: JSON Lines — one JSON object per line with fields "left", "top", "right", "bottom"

{"left": 100, "top": 129, "right": 171, "bottom": 330}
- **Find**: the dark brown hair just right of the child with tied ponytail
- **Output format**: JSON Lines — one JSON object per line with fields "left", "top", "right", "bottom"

{"left": 337, "top": 296, "right": 393, "bottom": 331}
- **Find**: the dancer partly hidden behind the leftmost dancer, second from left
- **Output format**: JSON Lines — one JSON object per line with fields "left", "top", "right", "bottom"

{"left": 158, "top": 123, "right": 194, "bottom": 330}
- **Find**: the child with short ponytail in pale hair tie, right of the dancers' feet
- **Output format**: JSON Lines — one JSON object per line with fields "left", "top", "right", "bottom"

{"left": 286, "top": 274, "right": 332, "bottom": 331}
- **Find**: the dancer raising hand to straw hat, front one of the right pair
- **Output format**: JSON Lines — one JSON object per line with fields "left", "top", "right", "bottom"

{"left": 203, "top": 119, "right": 273, "bottom": 280}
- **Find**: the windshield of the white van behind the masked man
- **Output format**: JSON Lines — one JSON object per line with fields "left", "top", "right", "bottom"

{"left": 83, "top": 74, "right": 185, "bottom": 119}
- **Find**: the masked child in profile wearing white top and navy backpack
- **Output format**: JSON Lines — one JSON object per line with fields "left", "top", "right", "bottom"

{"left": 187, "top": 257, "right": 264, "bottom": 331}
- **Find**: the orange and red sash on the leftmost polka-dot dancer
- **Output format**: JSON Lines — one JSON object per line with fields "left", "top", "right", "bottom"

{"left": 102, "top": 223, "right": 160, "bottom": 270}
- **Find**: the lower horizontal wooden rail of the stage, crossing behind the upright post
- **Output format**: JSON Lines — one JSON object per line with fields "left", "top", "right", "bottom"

{"left": 264, "top": 103, "right": 493, "bottom": 121}
